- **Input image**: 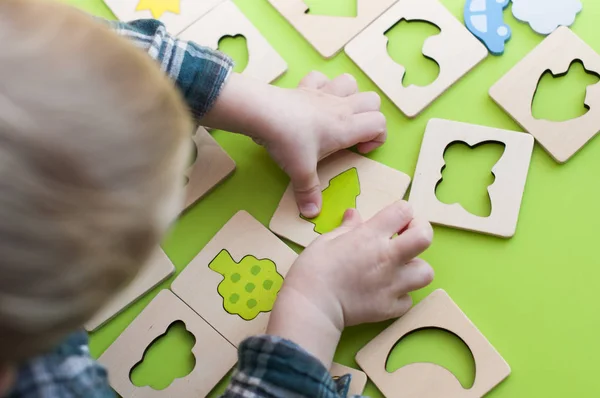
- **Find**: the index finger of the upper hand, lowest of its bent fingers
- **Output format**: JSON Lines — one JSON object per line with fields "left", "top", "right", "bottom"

{"left": 342, "top": 112, "right": 387, "bottom": 153}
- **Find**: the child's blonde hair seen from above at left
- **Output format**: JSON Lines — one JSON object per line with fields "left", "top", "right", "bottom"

{"left": 0, "top": 0, "right": 193, "bottom": 365}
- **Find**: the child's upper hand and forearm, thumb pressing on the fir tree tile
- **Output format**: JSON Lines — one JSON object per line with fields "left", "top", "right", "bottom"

{"left": 203, "top": 72, "right": 387, "bottom": 217}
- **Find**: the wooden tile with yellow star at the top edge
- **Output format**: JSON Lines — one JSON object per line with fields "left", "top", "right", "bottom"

{"left": 104, "top": 0, "right": 223, "bottom": 35}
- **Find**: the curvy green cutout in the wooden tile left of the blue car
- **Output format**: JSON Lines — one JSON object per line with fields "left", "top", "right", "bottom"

{"left": 385, "top": 19, "right": 441, "bottom": 87}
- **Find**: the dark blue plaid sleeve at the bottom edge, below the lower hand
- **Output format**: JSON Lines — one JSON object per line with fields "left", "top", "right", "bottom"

{"left": 223, "top": 335, "right": 364, "bottom": 398}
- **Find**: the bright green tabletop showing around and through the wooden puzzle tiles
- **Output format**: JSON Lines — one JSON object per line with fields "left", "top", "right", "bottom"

{"left": 67, "top": 0, "right": 600, "bottom": 398}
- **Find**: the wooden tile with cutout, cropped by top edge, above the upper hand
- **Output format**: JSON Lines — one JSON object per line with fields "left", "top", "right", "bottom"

{"left": 269, "top": 0, "right": 397, "bottom": 58}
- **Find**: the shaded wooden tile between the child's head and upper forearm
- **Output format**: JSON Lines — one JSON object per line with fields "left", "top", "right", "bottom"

{"left": 185, "top": 127, "right": 235, "bottom": 208}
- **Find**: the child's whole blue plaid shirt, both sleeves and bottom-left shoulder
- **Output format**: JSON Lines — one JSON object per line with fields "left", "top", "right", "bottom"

{"left": 8, "top": 20, "right": 358, "bottom": 398}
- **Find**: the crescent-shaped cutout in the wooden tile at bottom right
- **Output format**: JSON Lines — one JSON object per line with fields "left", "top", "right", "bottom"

{"left": 385, "top": 328, "right": 475, "bottom": 389}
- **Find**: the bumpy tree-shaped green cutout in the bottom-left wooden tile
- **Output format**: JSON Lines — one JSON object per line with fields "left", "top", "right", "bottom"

{"left": 129, "top": 321, "right": 196, "bottom": 391}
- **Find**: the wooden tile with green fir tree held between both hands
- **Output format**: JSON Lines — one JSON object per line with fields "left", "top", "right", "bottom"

{"left": 269, "top": 150, "right": 410, "bottom": 247}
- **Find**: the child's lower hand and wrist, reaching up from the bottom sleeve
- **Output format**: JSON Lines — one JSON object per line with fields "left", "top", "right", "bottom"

{"left": 268, "top": 201, "right": 433, "bottom": 366}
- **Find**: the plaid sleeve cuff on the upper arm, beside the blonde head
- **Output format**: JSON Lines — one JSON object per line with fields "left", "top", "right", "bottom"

{"left": 106, "top": 19, "right": 233, "bottom": 119}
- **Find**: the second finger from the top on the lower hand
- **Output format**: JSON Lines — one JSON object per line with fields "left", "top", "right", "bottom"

{"left": 390, "top": 218, "right": 433, "bottom": 263}
